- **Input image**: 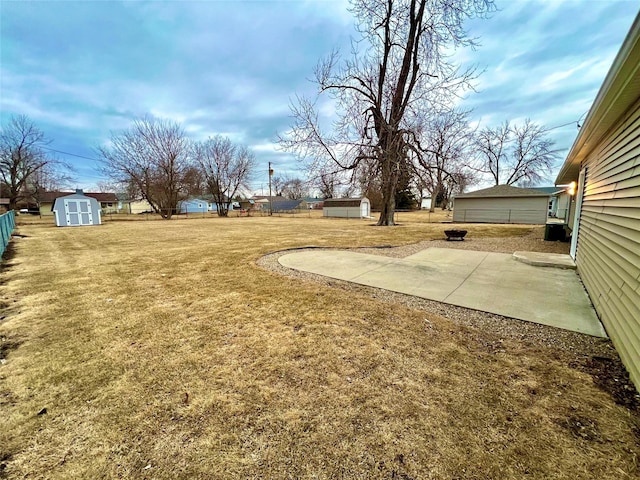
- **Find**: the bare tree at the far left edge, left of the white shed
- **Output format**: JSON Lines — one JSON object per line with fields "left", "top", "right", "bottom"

{"left": 0, "top": 115, "right": 54, "bottom": 210}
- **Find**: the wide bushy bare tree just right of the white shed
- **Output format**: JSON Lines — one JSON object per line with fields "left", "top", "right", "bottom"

{"left": 98, "top": 117, "right": 190, "bottom": 219}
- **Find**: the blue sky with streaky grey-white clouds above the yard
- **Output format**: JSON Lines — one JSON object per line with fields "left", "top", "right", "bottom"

{"left": 0, "top": 0, "right": 638, "bottom": 194}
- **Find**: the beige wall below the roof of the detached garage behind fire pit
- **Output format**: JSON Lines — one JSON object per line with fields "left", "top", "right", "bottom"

{"left": 453, "top": 197, "right": 549, "bottom": 225}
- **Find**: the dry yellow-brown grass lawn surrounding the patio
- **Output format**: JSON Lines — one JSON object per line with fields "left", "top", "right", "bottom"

{"left": 0, "top": 214, "right": 640, "bottom": 480}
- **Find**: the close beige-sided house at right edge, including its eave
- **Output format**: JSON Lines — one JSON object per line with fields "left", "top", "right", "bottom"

{"left": 556, "top": 14, "right": 640, "bottom": 388}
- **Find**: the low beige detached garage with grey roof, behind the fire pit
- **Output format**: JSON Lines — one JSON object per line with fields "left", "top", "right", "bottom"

{"left": 453, "top": 185, "right": 550, "bottom": 225}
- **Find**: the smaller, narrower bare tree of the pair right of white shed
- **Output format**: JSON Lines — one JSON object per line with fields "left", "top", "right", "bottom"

{"left": 194, "top": 135, "right": 255, "bottom": 217}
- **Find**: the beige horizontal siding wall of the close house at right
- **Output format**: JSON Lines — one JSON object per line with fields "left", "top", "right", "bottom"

{"left": 576, "top": 103, "right": 640, "bottom": 385}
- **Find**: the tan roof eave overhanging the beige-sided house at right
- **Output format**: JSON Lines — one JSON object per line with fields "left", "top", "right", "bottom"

{"left": 556, "top": 13, "right": 640, "bottom": 185}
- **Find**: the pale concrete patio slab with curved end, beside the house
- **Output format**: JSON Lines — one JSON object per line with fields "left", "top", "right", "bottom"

{"left": 279, "top": 248, "right": 607, "bottom": 337}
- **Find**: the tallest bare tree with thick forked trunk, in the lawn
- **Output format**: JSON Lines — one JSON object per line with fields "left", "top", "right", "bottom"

{"left": 280, "top": 0, "right": 494, "bottom": 225}
